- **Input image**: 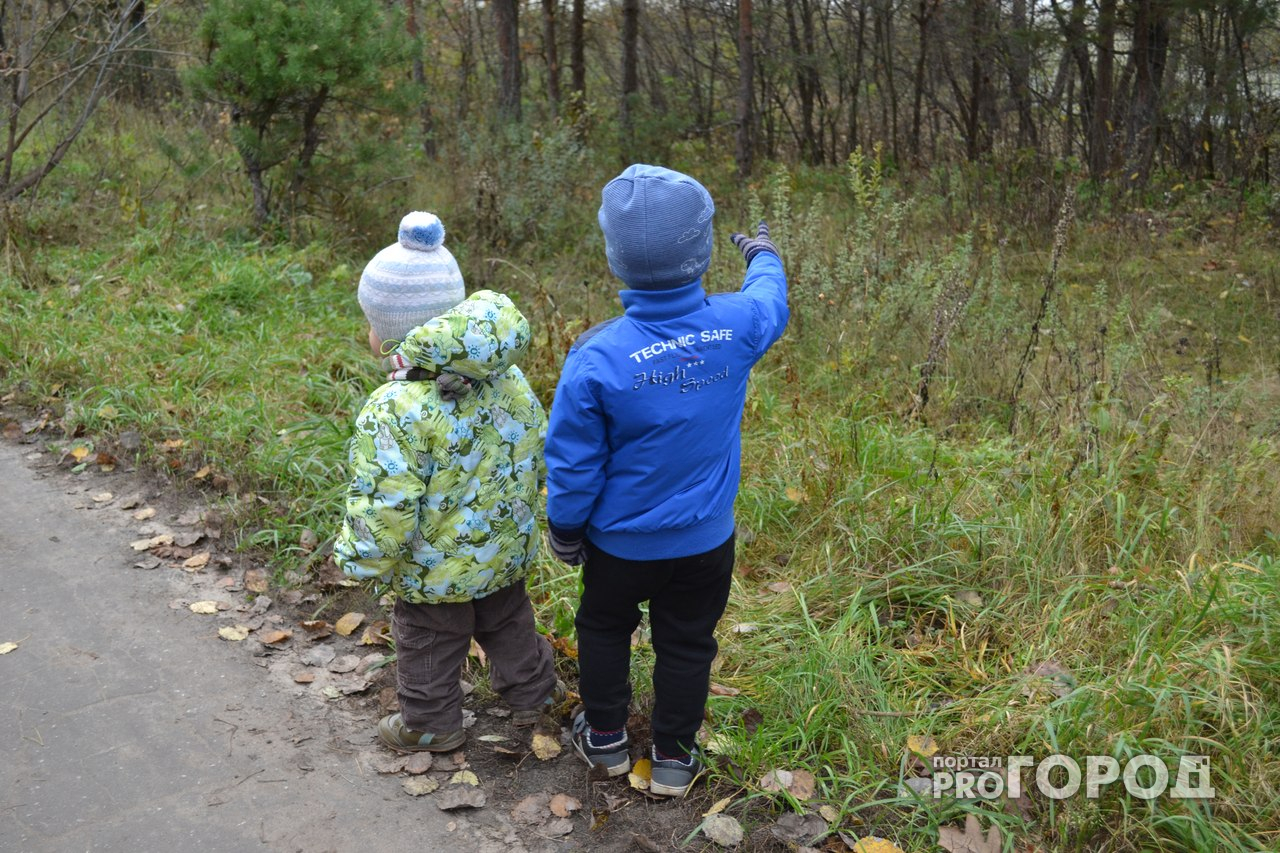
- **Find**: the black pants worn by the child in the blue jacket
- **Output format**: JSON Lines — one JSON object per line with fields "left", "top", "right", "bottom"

{"left": 575, "top": 535, "right": 733, "bottom": 756}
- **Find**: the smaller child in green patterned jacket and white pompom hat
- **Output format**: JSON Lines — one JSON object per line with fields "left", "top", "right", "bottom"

{"left": 334, "top": 213, "right": 557, "bottom": 752}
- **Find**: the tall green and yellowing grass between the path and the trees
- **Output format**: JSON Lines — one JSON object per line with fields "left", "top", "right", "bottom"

{"left": 0, "top": 111, "right": 1280, "bottom": 850}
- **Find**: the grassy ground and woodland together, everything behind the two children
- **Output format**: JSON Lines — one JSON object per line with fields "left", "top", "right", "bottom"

{"left": 0, "top": 0, "right": 1280, "bottom": 850}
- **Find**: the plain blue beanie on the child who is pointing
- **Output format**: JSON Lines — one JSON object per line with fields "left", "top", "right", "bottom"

{"left": 599, "top": 164, "right": 716, "bottom": 291}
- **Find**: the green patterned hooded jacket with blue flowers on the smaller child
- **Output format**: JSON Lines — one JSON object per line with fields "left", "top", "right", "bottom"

{"left": 334, "top": 291, "right": 547, "bottom": 603}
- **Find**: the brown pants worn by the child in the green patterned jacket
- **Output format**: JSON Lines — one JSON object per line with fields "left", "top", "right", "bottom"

{"left": 392, "top": 581, "right": 556, "bottom": 734}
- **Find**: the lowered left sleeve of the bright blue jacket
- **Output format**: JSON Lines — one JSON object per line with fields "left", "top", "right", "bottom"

{"left": 547, "top": 350, "right": 608, "bottom": 540}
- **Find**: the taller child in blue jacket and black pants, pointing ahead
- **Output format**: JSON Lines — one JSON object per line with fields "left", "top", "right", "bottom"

{"left": 547, "top": 165, "right": 788, "bottom": 797}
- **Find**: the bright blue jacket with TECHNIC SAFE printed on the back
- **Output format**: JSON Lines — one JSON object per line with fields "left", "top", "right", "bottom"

{"left": 547, "top": 252, "right": 788, "bottom": 560}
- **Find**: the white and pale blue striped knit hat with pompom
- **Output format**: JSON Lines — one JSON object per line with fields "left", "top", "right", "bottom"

{"left": 356, "top": 210, "right": 467, "bottom": 341}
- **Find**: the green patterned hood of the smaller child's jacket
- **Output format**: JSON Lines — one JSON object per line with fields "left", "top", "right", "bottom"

{"left": 397, "top": 291, "right": 530, "bottom": 380}
